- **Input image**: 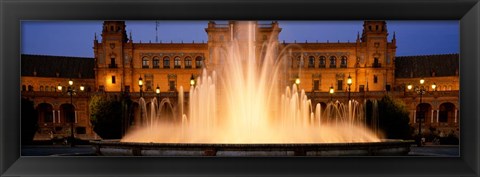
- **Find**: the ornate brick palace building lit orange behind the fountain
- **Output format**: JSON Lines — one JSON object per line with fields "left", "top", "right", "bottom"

{"left": 20, "top": 21, "right": 459, "bottom": 140}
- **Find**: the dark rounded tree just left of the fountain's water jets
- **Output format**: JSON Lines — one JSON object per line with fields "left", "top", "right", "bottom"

{"left": 89, "top": 95, "right": 122, "bottom": 139}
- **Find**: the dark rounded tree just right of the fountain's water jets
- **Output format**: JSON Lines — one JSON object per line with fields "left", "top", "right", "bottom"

{"left": 378, "top": 96, "right": 412, "bottom": 139}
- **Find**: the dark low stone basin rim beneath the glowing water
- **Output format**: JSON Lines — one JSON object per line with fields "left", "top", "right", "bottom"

{"left": 91, "top": 140, "right": 414, "bottom": 157}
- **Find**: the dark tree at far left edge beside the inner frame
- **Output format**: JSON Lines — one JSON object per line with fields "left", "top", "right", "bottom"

{"left": 21, "top": 98, "right": 38, "bottom": 144}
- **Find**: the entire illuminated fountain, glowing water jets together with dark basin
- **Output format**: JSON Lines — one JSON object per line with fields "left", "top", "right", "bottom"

{"left": 92, "top": 22, "right": 411, "bottom": 156}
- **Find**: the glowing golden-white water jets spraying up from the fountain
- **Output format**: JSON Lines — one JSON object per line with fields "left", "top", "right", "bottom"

{"left": 122, "top": 22, "right": 380, "bottom": 143}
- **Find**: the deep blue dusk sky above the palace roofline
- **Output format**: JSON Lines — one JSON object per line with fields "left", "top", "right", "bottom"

{"left": 21, "top": 21, "right": 460, "bottom": 57}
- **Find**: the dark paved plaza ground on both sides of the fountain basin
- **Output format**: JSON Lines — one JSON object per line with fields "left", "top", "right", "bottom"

{"left": 22, "top": 145, "right": 459, "bottom": 157}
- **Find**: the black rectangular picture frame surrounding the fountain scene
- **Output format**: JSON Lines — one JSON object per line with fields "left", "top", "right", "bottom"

{"left": 0, "top": 0, "right": 480, "bottom": 176}
